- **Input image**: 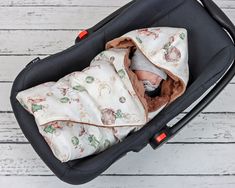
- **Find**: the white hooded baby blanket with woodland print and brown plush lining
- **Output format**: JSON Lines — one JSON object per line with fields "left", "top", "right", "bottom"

{"left": 17, "top": 27, "right": 189, "bottom": 162}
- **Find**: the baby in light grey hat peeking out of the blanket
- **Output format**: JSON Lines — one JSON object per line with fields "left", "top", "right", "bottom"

{"left": 130, "top": 49, "right": 167, "bottom": 96}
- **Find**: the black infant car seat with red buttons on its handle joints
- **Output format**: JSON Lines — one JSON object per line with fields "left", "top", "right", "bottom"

{"left": 11, "top": 0, "right": 235, "bottom": 184}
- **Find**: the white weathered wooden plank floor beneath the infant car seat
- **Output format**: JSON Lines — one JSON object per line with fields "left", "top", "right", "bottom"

{"left": 0, "top": 0, "right": 235, "bottom": 188}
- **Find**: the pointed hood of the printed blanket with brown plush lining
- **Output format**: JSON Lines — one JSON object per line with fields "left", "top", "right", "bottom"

{"left": 106, "top": 27, "right": 189, "bottom": 115}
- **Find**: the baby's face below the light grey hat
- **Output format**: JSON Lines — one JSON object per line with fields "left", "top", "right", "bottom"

{"left": 134, "top": 70, "right": 162, "bottom": 85}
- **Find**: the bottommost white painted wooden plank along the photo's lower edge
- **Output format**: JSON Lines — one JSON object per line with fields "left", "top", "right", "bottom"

{"left": 0, "top": 176, "right": 235, "bottom": 188}
